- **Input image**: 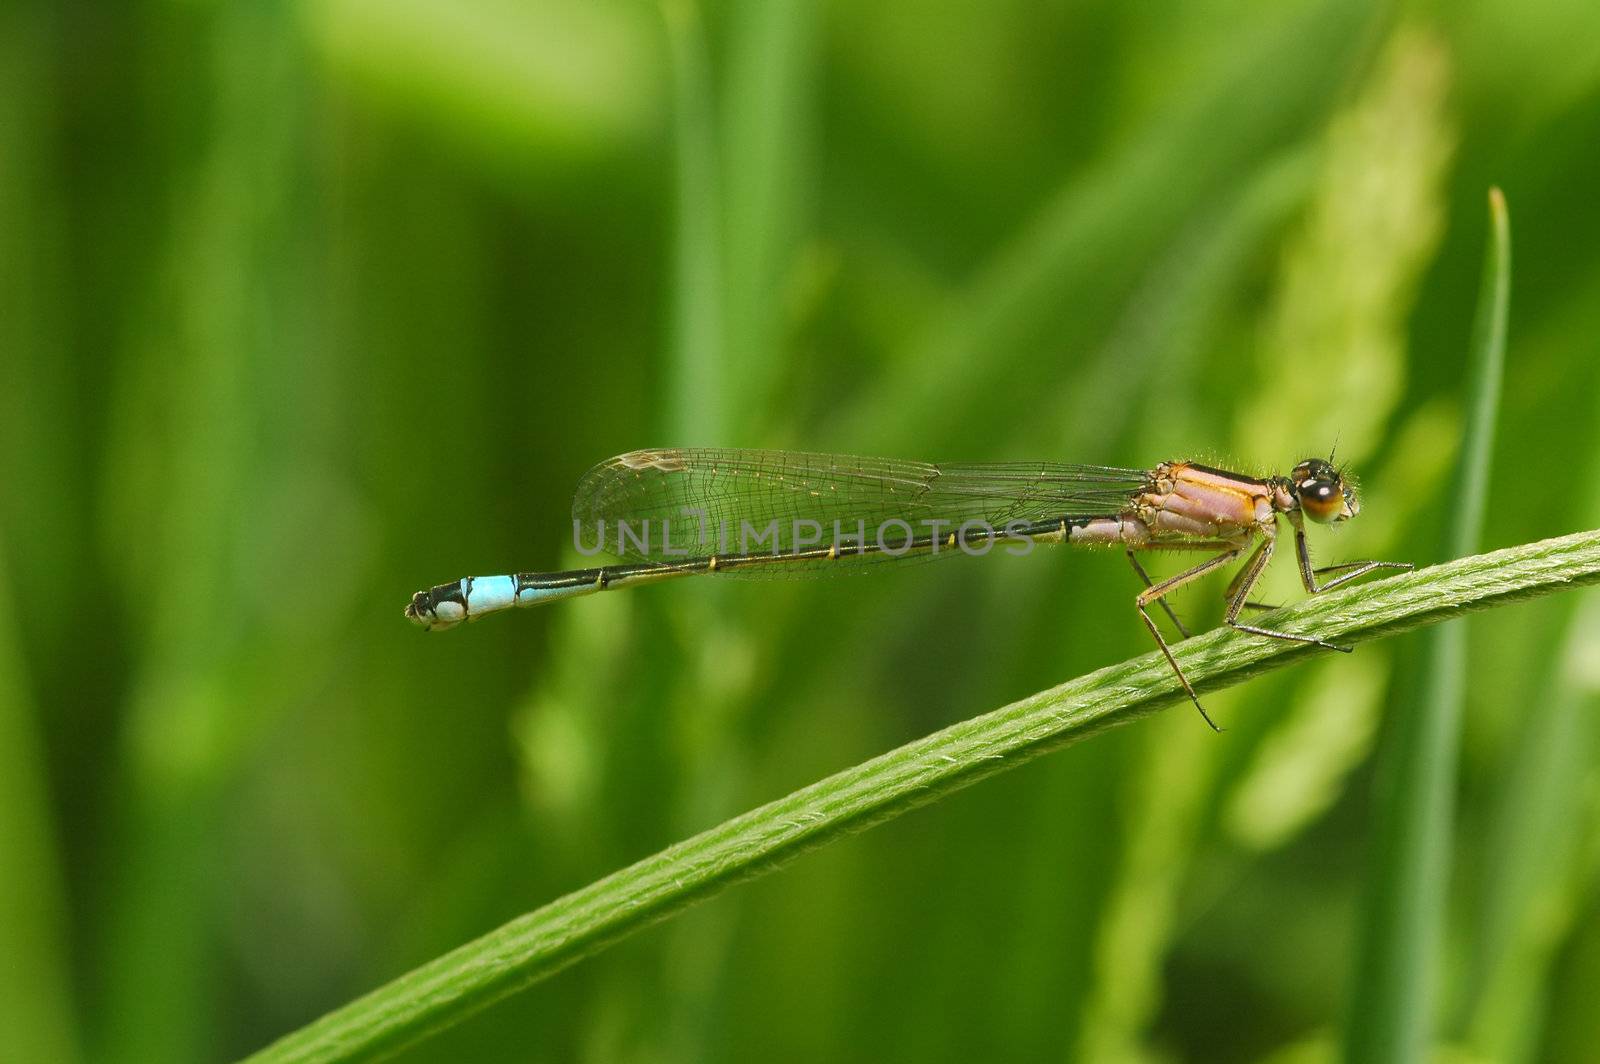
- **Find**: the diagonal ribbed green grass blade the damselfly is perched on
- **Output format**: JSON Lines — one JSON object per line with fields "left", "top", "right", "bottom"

{"left": 240, "top": 531, "right": 1600, "bottom": 1062}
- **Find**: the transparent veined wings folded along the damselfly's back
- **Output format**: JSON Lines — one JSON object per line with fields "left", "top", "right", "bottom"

{"left": 573, "top": 448, "right": 1147, "bottom": 576}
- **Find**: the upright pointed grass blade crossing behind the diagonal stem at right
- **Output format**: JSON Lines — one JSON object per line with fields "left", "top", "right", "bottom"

{"left": 1344, "top": 189, "right": 1510, "bottom": 1064}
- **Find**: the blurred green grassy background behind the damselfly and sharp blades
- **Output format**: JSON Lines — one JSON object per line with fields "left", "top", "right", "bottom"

{"left": 0, "top": 0, "right": 1600, "bottom": 1064}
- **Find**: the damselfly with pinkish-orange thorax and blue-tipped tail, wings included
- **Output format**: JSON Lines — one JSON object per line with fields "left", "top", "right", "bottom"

{"left": 405, "top": 448, "right": 1411, "bottom": 728}
